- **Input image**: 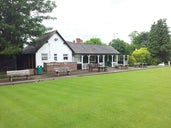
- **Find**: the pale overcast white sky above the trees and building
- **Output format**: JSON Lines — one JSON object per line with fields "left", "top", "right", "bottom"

{"left": 43, "top": 0, "right": 171, "bottom": 44}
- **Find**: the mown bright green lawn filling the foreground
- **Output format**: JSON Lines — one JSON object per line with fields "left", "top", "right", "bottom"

{"left": 0, "top": 67, "right": 171, "bottom": 128}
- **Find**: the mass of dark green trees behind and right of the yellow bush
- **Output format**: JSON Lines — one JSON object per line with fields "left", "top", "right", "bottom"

{"left": 129, "top": 19, "right": 171, "bottom": 64}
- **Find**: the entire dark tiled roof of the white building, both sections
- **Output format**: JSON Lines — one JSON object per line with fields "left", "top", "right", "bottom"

{"left": 23, "top": 31, "right": 120, "bottom": 55}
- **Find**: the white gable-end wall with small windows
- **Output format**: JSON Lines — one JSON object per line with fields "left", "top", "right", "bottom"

{"left": 36, "top": 34, "right": 72, "bottom": 67}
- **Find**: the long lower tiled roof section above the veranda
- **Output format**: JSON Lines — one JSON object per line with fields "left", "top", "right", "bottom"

{"left": 66, "top": 42, "right": 120, "bottom": 55}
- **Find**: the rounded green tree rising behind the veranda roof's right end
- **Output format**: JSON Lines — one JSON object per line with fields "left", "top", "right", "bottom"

{"left": 109, "top": 38, "right": 129, "bottom": 55}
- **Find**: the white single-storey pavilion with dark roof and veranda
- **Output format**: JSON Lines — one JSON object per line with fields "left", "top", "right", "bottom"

{"left": 23, "top": 31, "right": 124, "bottom": 69}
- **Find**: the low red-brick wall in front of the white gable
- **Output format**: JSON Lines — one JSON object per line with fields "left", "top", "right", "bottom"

{"left": 44, "top": 62, "right": 77, "bottom": 72}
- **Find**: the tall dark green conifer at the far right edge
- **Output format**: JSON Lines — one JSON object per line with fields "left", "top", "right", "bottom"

{"left": 148, "top": 19, "right": 171, "bottom": 61}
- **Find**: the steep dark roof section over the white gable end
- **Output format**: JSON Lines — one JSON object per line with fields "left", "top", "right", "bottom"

{"left": 23, "top": 30, "right": 65, "bottom": 54}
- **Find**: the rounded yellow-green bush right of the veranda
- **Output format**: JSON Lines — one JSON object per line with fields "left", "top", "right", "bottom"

{"left": 132, "top": 48, "right": 151, "bottom": 63}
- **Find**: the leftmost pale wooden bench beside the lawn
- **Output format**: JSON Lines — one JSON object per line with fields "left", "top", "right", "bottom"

{"left": 6, "top": 69, "right": 30, "bottom": 82}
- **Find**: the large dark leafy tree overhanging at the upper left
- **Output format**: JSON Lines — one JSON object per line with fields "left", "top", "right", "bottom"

{"left": 0, "top": 0, "right": 56, "bottom": 54}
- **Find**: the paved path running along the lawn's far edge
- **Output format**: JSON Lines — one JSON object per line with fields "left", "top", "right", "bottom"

{"left": 0, "top": 66, "right": 158, "bottom": 86}
